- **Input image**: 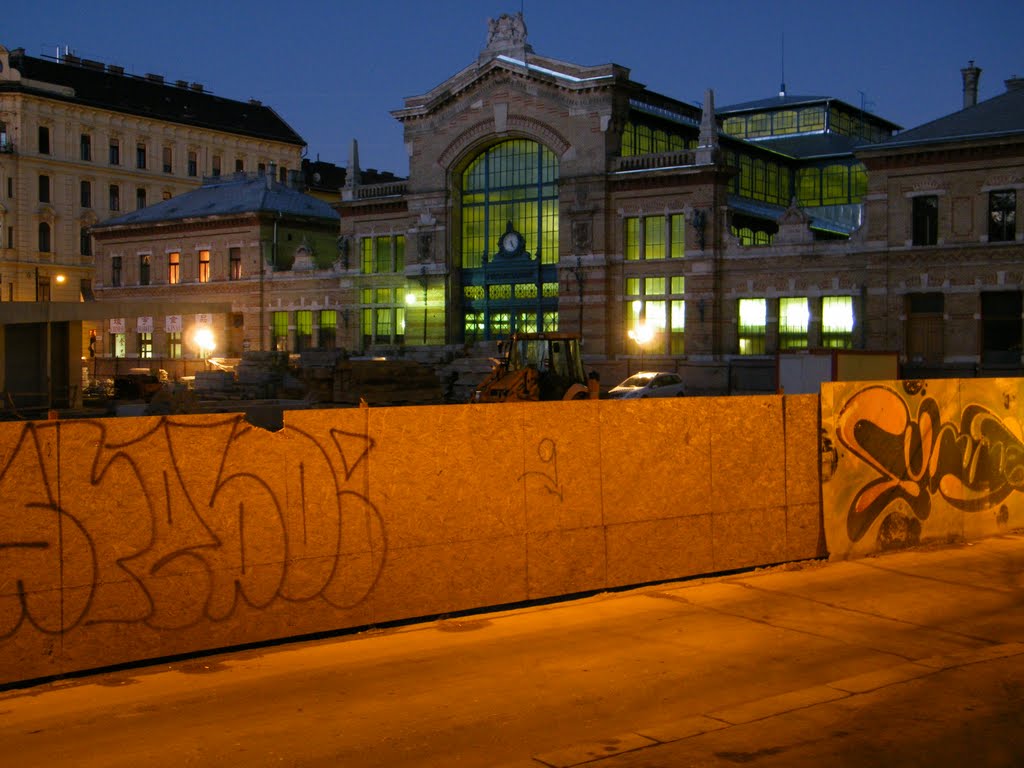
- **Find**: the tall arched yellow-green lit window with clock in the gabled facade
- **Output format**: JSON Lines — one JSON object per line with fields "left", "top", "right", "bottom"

{"left": 460, "top": 139, "right": 558, "bottom": 341}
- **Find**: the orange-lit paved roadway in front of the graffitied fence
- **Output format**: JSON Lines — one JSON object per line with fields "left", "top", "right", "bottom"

{"left": 0, "top": 532, "right": 1024, "bottom": 768}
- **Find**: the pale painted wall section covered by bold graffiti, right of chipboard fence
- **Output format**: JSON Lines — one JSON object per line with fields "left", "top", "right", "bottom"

{"left": 821, "top": 379, "right": 1024, "bottom": 559}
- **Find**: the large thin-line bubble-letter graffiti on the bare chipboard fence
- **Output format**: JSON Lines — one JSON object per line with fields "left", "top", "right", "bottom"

{"left": 0, "top": 415, "right": 387, "bottom": 640}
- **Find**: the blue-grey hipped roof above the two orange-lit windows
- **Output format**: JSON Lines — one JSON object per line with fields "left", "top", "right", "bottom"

{"left": 93, "top": 173, "right": 340, "bottom": 229}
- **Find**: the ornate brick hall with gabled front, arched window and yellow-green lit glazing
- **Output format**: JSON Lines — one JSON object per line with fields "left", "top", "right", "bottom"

{"left": 337, "top": 14, "right": 1024, "bottom": 393}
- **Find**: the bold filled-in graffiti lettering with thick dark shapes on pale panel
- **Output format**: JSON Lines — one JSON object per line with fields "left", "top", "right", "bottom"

{"left": 836, "top": 386, "right": 1024, "bottom": 542}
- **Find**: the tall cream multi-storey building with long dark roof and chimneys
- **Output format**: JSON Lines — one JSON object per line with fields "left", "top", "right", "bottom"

{"left": 0, "top": 46, "right": 305, "bottom": 301}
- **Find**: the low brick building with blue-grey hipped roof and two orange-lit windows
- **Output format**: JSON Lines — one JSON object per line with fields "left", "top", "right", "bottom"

{"left": 92, "top": 173, "right": 337, "bottom": 378}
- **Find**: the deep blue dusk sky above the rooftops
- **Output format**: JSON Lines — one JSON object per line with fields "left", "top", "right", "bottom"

{"left": 0, "top": 0, "right": 1024, "bottom": 176}
